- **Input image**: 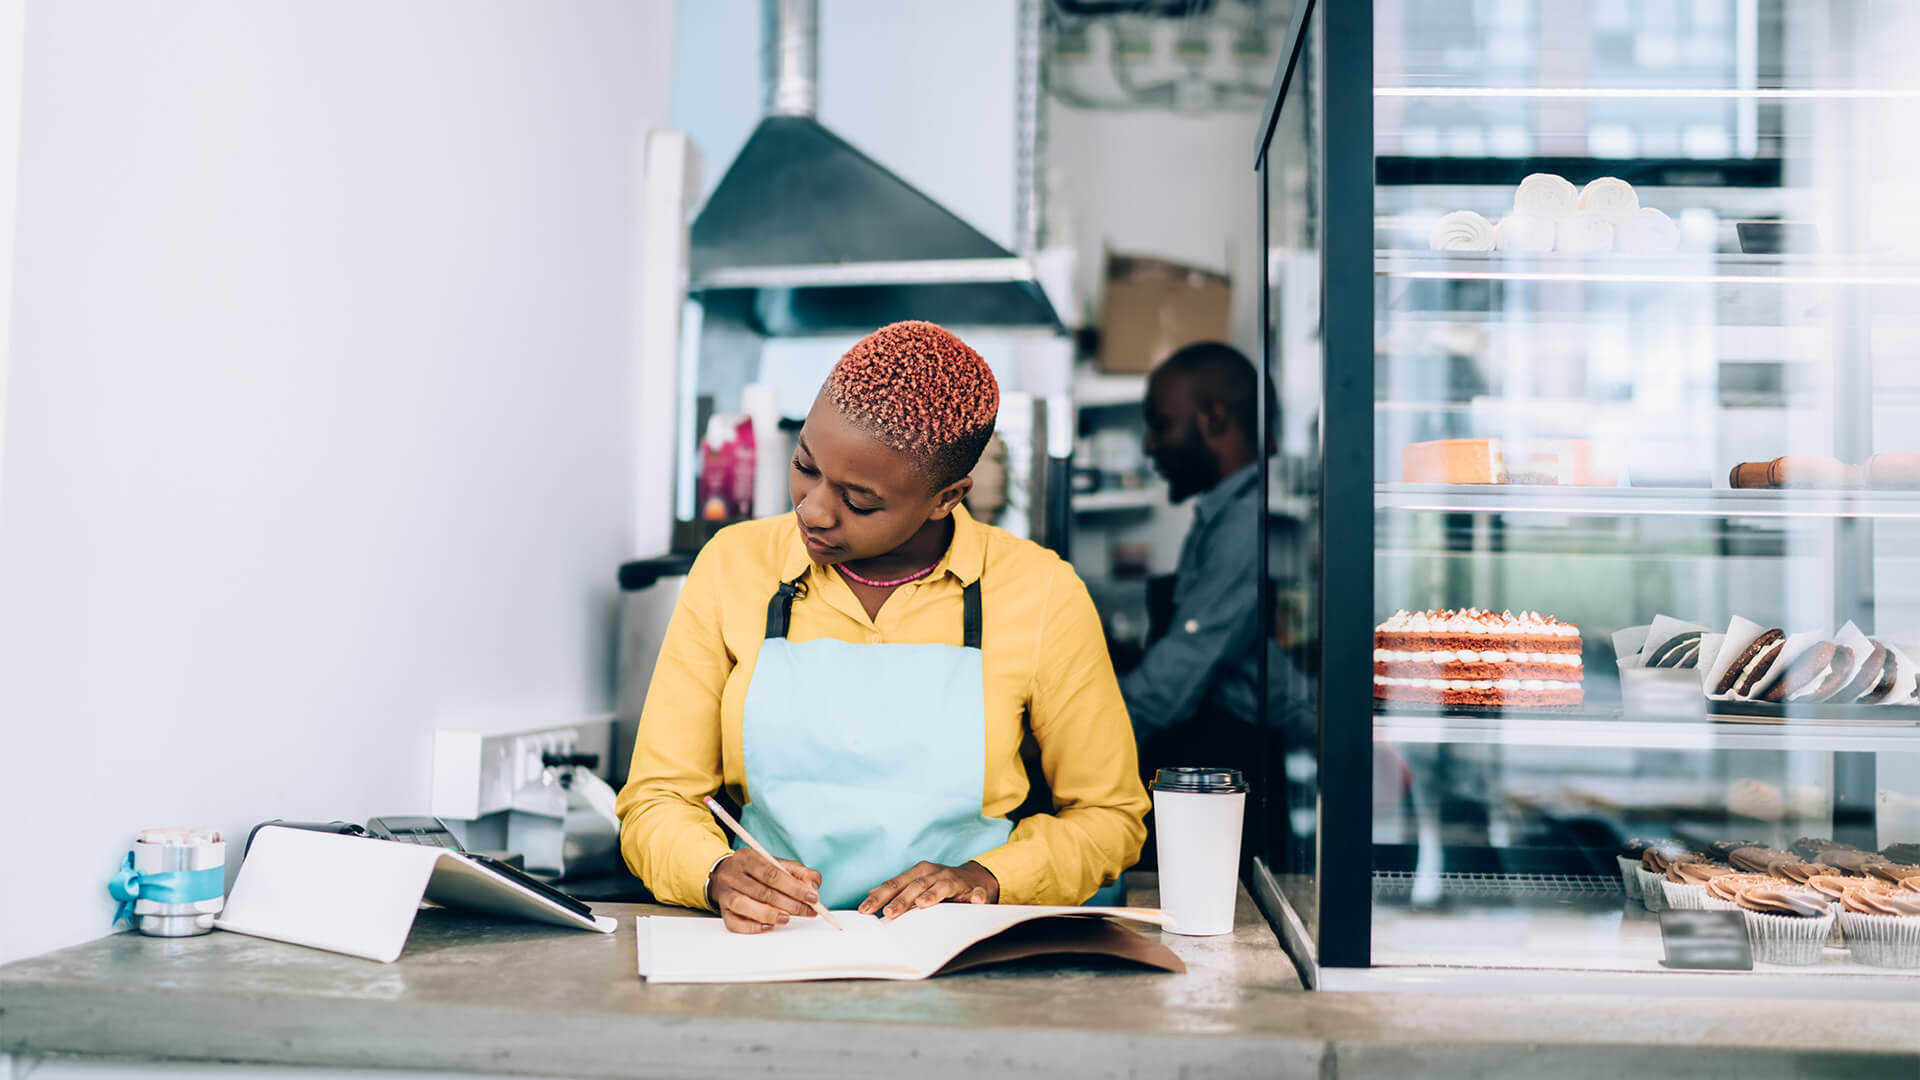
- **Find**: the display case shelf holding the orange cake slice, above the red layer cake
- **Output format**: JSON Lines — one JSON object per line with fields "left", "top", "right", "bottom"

{"left": 1373, "top": 484, "right": 1920, "bottom": 519}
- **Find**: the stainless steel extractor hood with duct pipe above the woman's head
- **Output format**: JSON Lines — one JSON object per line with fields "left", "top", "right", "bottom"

{"left": 689, "top": 0, "right": 1060, "bottom": 334}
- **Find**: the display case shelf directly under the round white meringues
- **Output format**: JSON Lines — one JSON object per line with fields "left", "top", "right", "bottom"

{"left": 1373, "top": 250, "right": 1920, "bottom": 286}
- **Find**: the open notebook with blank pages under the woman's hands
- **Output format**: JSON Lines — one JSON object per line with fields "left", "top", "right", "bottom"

{"left": 636, "top": 903, "right": 1187, "bottom": 982}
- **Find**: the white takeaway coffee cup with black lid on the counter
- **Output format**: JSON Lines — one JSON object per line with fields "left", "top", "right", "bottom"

{"left": 1154, "top": 767, "right": 1246, "bottom": 936}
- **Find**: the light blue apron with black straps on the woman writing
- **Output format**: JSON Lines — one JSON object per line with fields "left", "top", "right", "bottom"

{"left": 741, "top": 578, "right": 1014, "bottom": 909}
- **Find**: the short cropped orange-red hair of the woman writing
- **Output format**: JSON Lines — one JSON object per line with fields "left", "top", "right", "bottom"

{"left": 826, "top": 323, "right": 1000, "bottom": 490}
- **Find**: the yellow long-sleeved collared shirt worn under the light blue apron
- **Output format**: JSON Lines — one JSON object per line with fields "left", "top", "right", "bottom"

{"left": 618, "top": 507, "right": 1148, "bottom": 907}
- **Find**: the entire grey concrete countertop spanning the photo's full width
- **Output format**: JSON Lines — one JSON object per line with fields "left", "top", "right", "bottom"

{"left": 11, "top": 878, "right": 1920, "bottom": 1080}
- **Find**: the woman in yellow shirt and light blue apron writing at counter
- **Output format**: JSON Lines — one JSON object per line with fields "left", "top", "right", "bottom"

{"left": 618, "top": 323, "right": 1148, "bottom": 932}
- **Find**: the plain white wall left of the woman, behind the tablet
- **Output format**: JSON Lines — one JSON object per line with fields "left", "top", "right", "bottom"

{"left": 0, "top": 0, "right": 672, "bottom": 961}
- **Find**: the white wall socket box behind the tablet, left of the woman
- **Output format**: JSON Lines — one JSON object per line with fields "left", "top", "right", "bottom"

{"left": 432, "top": 715, "right": 612, "bottom": 821}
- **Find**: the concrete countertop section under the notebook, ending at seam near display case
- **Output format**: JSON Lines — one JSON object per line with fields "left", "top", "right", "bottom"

{"left": 0, "top": 888, "right": 1313, "bottom": 1076}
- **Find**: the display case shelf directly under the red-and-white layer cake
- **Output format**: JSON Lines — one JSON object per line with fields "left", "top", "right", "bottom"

{"left": 1373, "top": 705, "right": 1920, "bottom": 753}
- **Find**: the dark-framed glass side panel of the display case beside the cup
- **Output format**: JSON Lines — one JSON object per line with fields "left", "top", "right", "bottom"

{"left": 1254, "top": 0, "right": 1373, "bottom": 980}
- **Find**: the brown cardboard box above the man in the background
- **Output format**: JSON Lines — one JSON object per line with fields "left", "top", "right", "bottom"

{"left": 1098, "top": 252, "right": 1233, "bottom": 373}
